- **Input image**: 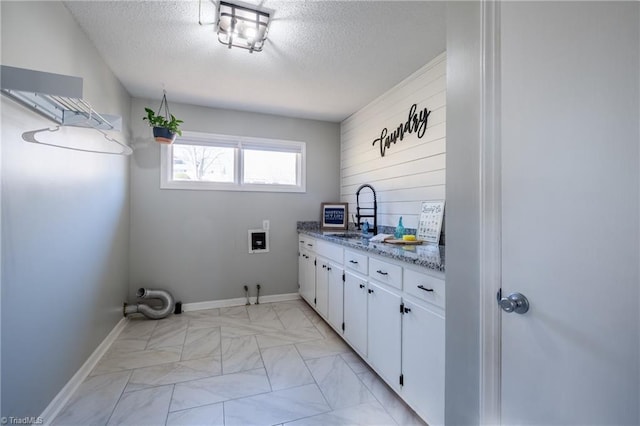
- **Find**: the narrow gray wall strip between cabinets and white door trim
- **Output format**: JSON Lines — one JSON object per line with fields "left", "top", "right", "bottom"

{"left": 445, "top": 2, "right": 482, "bottom": 425}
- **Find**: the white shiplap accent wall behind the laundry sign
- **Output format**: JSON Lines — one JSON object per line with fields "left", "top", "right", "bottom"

{"left": 340, "top": 53, "right": 446, "bottom": 233}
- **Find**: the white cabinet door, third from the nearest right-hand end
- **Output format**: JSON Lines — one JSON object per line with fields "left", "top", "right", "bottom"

{"left": 344, "top": 272, "right": 367, "bottom": 357}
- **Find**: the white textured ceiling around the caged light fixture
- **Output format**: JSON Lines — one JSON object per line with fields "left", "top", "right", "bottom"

{"left": 65, "top": 0, "right": 445, "bottom": 121}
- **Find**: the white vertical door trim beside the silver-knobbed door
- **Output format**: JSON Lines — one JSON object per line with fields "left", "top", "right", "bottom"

{"left": 479, "top": 1, "right": 502, "bottom": 425}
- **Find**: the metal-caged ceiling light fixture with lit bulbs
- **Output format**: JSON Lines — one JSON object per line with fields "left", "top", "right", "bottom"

{"left": 216, "top": 1, "right": 270, "bottom": 53}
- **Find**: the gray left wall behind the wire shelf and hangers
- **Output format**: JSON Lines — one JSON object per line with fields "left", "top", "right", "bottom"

{"left": 0, "top": 2, "right": 130, "bottom": 420}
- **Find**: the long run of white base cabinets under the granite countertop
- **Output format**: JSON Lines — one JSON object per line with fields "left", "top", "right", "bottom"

{"left": 298, "top": 234, "right": 445, "bottom": 425}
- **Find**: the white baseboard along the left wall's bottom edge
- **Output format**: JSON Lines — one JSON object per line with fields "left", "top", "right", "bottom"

{"left": 40, "top": 318, "right": 128, "bottom": 425}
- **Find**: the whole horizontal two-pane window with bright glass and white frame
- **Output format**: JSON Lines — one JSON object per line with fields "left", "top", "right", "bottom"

{"left": 160, "top": 132, "right": 306, "bottom": 192}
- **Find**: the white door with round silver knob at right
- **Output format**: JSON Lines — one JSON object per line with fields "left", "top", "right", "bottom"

{"left": 500, "top": 2, "right": 640, "bottom": 425}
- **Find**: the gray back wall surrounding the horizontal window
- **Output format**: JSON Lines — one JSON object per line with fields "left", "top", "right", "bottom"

{"left": 129, "top": 97, "right": 340, "bottom": 303}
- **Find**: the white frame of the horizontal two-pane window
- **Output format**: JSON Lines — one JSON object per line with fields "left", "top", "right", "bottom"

{"left": 160, "top": 131, "right": 307, "bottom": 192}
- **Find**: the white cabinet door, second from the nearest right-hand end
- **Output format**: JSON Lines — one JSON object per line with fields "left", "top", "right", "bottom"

{"left": 367, "top": 281, "right": 402, "bottom": 389}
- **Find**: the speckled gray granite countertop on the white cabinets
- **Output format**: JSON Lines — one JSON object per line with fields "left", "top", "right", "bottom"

{"left": 298, "top": 222, "right": 444, "bottom": 272}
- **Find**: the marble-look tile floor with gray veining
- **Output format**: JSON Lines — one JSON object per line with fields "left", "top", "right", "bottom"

{"left": 53, "top": 300, "right": 425, "bottom": 426}
